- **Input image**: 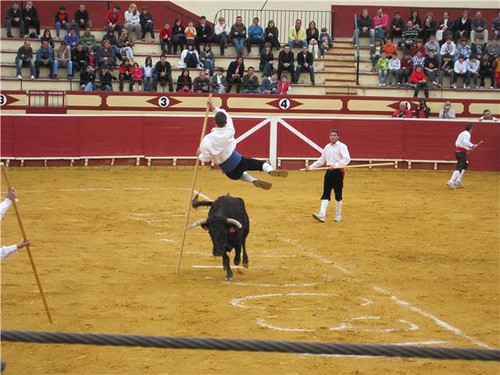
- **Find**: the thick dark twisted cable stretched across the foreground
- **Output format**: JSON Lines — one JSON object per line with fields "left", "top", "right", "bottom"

{"left": 1, "top": 330, "right": 500, "bottom": 361}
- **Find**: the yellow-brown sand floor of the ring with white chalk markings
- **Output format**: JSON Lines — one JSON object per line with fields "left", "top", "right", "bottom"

{"left": 1, "top": 167, "right": 500, "bottom": 375}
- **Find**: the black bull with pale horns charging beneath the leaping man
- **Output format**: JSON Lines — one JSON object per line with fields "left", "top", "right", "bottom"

{"left": 189, "top": 194, "right": 250, "bottom": 280}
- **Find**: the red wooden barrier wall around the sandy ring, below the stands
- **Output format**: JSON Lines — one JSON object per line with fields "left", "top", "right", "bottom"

{"left": 1, "top": 115, "right": 500, "bottom": 171}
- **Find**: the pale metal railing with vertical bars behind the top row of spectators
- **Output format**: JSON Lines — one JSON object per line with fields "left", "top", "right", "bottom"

{"left": 214, "top": 9, "right": 335, "bottom": 45}
